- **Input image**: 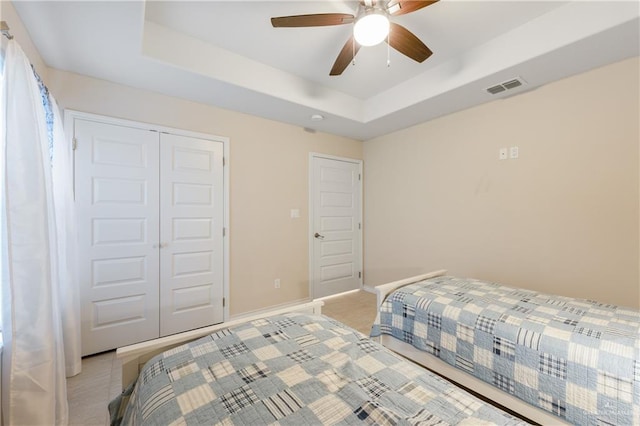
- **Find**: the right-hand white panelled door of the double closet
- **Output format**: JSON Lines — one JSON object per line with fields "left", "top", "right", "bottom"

{"left": 160, "top": 133, "right": 224, "bottom": 336}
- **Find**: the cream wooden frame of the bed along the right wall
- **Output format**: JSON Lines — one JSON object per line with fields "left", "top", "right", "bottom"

{"left": 375, "top": 269, "right": 570, "bottom": 425}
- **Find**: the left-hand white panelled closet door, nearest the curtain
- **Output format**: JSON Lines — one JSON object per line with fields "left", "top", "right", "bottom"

{"left": 74, "top": 120, "right": 159, "bottom": 355}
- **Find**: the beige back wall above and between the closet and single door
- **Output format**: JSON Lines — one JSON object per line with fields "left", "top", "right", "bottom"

{"left": 48, "top": 69, "right": 362, "bottom": 315}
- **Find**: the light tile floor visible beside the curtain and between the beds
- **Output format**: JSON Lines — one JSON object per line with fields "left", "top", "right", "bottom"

{"left": 67, "top": 291, "right": 376, "bottom": 426}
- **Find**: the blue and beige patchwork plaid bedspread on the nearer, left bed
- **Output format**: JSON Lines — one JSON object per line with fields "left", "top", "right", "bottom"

{"left": 115, "top": 314, "right": 522, "bottom": 425}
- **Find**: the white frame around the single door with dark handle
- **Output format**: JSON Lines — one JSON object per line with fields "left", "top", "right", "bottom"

{"left": 307, "top": 152, "right": 364, "bottom": 299}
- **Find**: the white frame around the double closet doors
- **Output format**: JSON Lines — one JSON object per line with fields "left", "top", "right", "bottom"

{"left": 64, "top": 109, "right": 231, "bottom": 322}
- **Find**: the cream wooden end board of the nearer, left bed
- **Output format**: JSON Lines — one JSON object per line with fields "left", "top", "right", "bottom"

{"left": 116, "top": 300, "right": 324, "bottom": 390}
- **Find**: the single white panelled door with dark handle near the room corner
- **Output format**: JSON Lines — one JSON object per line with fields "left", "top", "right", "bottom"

{"left": 310, "top": 154, "right": 362, "bottom": 298}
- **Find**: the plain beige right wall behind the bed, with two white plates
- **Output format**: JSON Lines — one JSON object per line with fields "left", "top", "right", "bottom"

{"left": 364, "top": 58, "right": 640, "bottom": 307}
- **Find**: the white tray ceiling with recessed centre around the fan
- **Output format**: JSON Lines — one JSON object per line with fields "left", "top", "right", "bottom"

{"left": 14, "top": 0, "right": 640, "bottom": 140}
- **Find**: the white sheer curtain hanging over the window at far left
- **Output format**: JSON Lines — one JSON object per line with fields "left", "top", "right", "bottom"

{"left": 0, "top": 40, "right": 80, "bottom": 425}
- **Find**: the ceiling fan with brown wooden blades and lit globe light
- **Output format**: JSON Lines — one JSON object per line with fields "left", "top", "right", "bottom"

{"left": 271, "top": 0, "right": 438, "bottom": 75}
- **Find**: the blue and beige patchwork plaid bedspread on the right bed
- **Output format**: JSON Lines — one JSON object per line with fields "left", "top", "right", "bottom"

{"left": 371, "top": 277, "right": 640, "bottom": 425}
